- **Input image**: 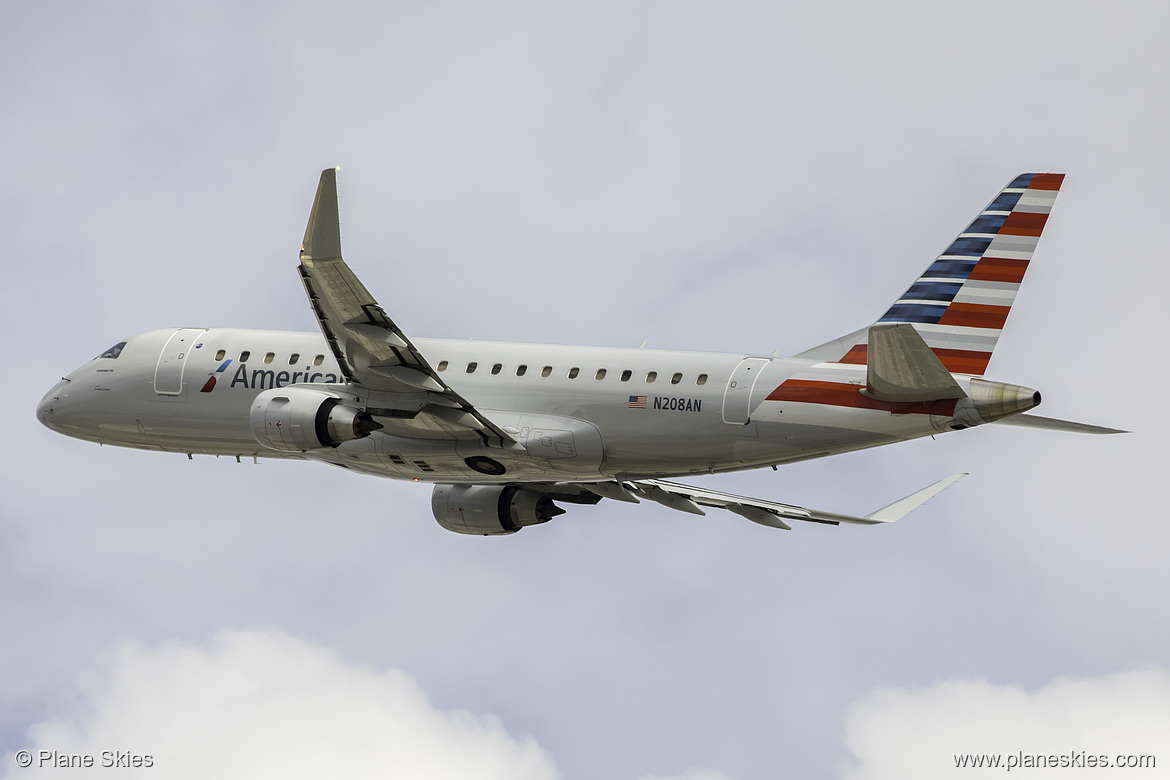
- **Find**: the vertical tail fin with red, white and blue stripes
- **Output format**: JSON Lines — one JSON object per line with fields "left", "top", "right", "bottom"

{"left": 839, "top": 173, "right": 1065, "bottom": 377}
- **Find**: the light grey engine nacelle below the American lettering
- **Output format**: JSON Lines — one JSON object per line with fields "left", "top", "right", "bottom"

{"left": 249, "top": 387, "right": 381, "bottom": 453}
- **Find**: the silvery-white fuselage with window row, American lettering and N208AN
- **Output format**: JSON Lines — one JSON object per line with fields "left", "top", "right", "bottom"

{"left": 37, "top": 329, "right": 951, "bottom": 484}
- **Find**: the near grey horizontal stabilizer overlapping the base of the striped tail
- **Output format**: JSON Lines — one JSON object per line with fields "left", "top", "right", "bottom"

{"left": 865, "top": 323, "right": 966, "bottom": 403}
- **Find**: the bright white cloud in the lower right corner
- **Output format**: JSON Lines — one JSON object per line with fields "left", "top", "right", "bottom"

{"left": 844, "top": 669, "right": 1170, "bottom": 780}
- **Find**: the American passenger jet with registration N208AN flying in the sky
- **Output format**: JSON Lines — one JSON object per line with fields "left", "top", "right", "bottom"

{"left": 36, "top": 168, "right": 1126, "bottom": 536}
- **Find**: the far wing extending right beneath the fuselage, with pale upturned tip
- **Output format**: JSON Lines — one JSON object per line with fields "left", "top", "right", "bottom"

{"left": 525, "top": 474, "right": 966, "bottom": 531}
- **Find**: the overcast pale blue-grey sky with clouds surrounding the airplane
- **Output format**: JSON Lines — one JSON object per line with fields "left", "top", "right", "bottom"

{"left": 0, "top": 0, "right": 1170, "bottom": 780}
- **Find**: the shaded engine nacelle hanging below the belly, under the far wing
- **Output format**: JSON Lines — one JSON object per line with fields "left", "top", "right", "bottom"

{"left": 431, "top": 485, "right": 565, "bottom": 537}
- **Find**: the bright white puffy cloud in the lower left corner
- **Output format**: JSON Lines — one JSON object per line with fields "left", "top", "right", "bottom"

{"left": 4, "top": 629, "right": 727, "bottom": 780}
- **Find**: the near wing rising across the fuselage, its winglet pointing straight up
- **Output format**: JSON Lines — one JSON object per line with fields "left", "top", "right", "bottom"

{"left": 300, "top": 168, "right": 512, "bottom": 444}
